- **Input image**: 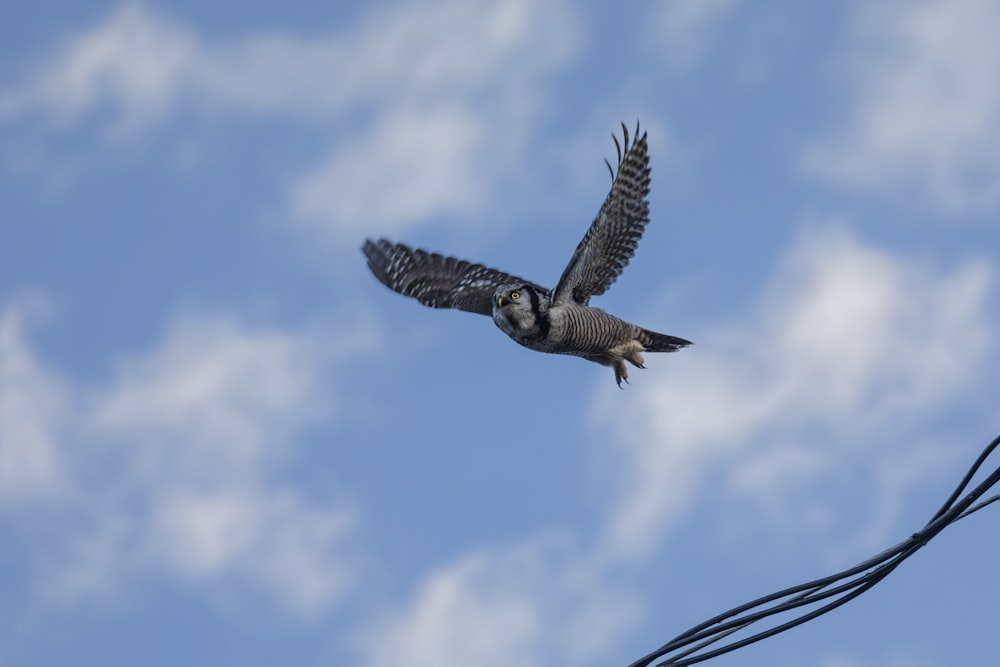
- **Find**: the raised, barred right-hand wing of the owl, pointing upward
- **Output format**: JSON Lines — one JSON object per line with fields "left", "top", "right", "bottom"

{"left": 553, "top": 123, "right": 649, "bottom": 306}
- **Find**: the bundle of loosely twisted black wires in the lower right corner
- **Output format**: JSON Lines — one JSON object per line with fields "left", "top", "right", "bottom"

{"left": 629, "top": 436, "right": 1000, "bottom": 667}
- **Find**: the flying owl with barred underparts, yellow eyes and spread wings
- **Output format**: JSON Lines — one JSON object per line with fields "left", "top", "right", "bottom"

{"left": 361, "top": 123, "right": 692, "bottom": 387}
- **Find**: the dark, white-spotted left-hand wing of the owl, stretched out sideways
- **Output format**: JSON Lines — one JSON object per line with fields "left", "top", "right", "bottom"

{"left": 361, "top": 239, "right": 547, "bottom": 315}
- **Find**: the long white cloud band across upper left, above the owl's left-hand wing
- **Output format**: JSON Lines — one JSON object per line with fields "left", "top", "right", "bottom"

{"left": 0, "top": 0, "right": 579, "bottom": 235}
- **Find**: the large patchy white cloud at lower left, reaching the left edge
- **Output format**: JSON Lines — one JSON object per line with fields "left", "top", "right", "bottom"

{"left": 0, "top": 304, "right": 367, "bottom": 614}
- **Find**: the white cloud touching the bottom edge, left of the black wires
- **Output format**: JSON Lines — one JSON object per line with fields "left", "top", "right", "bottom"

{"left": 364, "top": 538, "right": 637, "bottom": 667}
